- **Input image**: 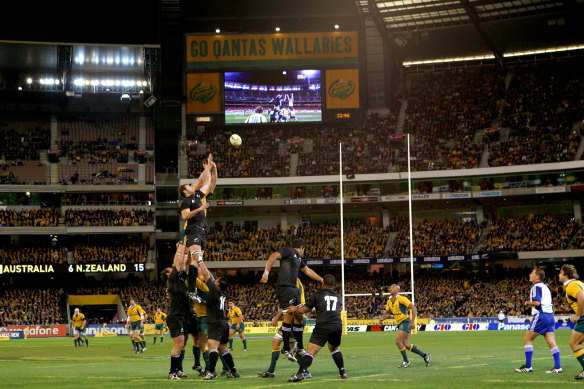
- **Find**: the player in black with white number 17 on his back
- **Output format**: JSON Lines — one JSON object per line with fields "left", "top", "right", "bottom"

{"left": 288, "top": 274, "right": 349, "bottom": 382}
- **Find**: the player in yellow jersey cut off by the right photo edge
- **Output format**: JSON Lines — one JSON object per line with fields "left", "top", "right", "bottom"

{"left": 558, "top": 265, "right": 584, "bottom": 380}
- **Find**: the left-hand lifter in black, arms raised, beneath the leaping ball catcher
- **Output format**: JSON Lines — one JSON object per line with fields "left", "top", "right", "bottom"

{"left": 160, "top": 238, "right": 190, "bottom": 380}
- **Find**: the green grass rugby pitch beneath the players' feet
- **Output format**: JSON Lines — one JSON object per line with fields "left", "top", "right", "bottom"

{"left": 0, "top": 330, "right": 582, "bottom": 389}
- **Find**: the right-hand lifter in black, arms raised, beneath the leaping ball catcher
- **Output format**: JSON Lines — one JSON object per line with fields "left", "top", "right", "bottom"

{"left": 199, "top": 255, "right": 239, "bottom": 380}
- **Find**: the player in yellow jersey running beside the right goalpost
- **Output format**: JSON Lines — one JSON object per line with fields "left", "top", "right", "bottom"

{"left": 379, "top": 284, "right": 432, "bottom": 368}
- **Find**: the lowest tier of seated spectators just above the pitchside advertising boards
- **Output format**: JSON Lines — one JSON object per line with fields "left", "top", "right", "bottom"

{"left": 0, "top": 267, "right": 570, "bottom": 325}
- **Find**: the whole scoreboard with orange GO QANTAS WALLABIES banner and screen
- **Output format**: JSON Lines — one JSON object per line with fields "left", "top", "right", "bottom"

{"left": 184, "top": 31, "right": 366, "bottom": 125}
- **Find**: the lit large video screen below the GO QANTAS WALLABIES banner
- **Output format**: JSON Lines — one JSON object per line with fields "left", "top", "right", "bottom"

{"left": 225, "top": 70, "right": 322, "bottom": 124}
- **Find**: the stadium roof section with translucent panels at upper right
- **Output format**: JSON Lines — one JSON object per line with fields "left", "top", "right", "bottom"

{"left": 355, "top": 0, "right": 584, "bottom": 61}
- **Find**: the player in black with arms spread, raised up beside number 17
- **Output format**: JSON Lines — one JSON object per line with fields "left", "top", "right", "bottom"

{"left": 260, "top": 239, "right": 322, "bottom": 362}
